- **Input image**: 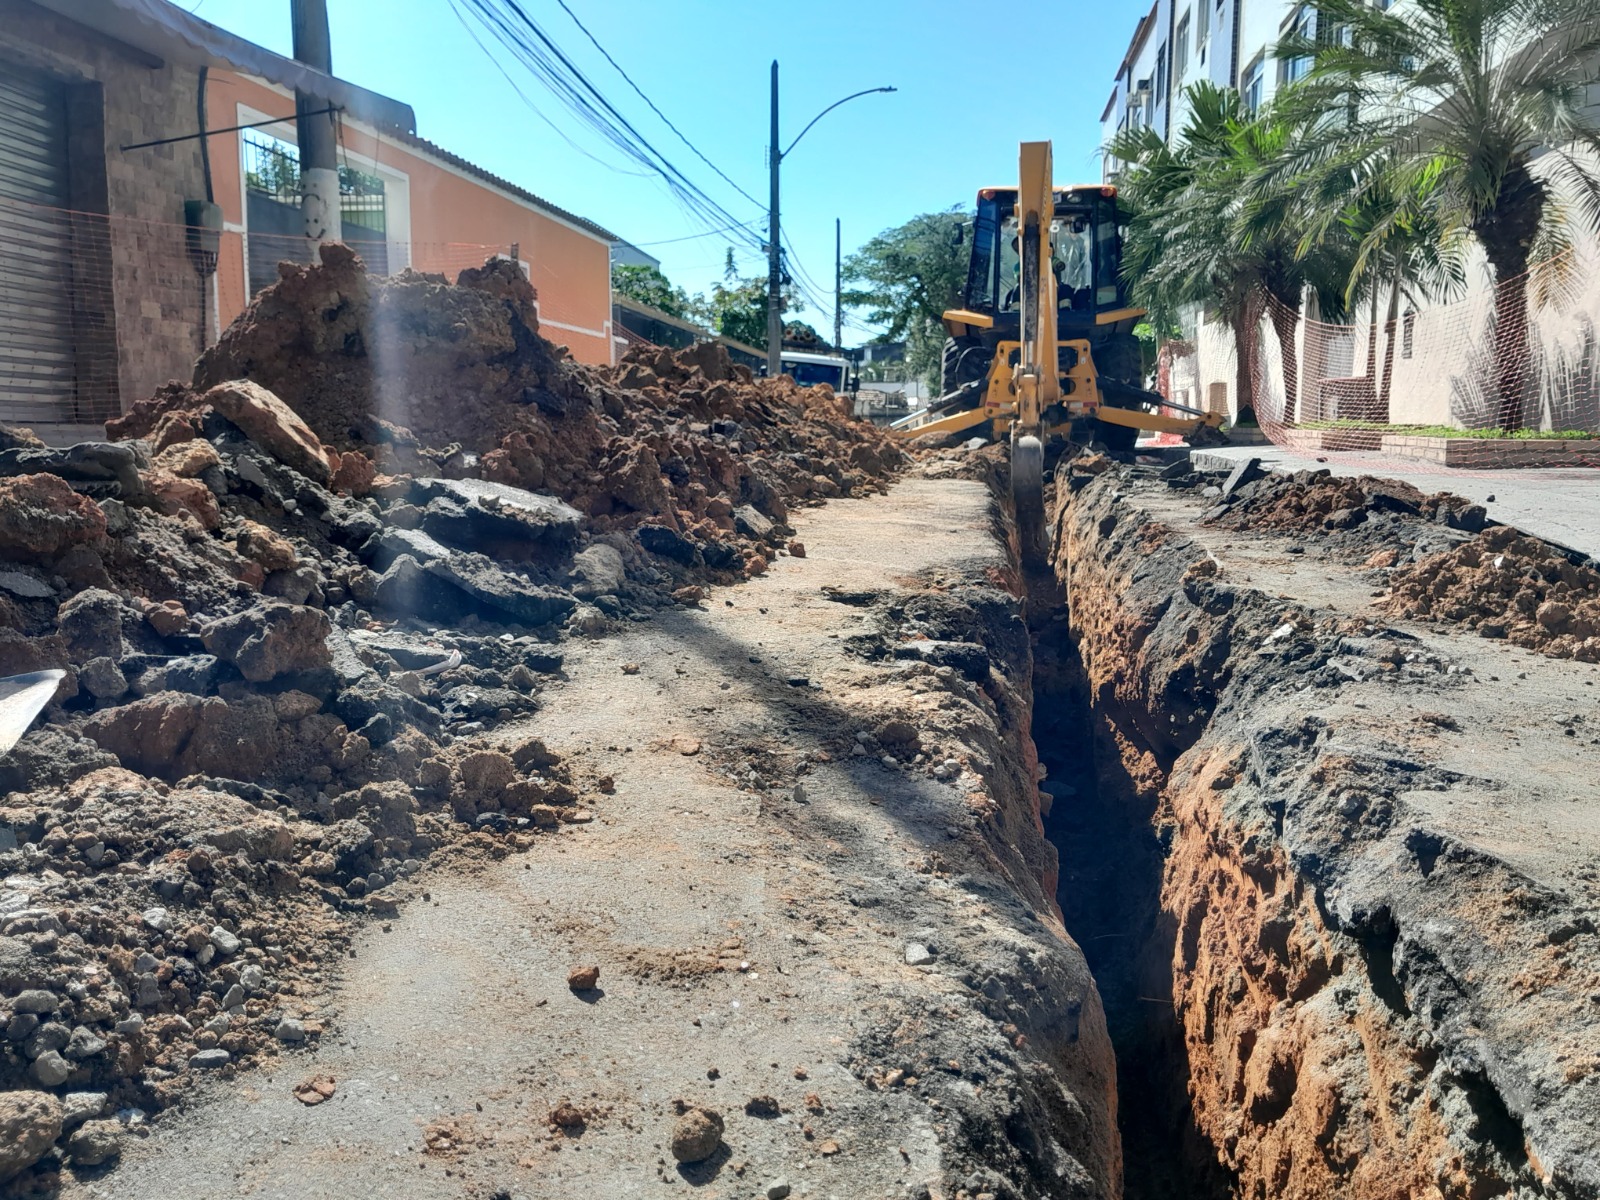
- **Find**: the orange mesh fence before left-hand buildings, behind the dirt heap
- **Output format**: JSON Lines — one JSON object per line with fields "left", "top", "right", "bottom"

{"left": 0, "top": 200, "right": 613, "bottom": 437}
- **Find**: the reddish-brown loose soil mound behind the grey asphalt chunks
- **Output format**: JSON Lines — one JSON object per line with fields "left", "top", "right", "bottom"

{"left": 109, "top": 246, "right": 906, "bottom": 570}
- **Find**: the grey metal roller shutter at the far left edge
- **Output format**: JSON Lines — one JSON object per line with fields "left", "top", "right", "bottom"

{"left": 0, "top": 64, "right": 77, "bottom": 424}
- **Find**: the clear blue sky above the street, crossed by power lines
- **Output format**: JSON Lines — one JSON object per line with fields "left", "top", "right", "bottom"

{"left": 190, "top": 0, "right": 1146, "bottom": 344}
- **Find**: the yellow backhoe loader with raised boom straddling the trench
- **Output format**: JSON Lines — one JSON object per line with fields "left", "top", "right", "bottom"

{"left": 890, "top": 142, "right": 1226, "bottom": 563}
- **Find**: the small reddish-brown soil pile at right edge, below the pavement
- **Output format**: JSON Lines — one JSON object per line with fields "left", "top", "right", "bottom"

{"left": 1387, "top": 525, "right": 1600, "bottom": 662}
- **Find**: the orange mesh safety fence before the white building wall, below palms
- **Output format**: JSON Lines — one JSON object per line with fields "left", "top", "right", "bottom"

{"left": 1235, "top": 251, "right": 1600, "bottom": 470}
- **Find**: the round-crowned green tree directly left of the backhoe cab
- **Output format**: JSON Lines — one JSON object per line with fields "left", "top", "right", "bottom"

{"left": 843, "top": 208, "right": 971, "bottom": 389}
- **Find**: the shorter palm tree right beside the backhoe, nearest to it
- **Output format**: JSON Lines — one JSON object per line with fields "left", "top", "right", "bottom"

{"left": 1107, "top": 80, "right": 1350, "bottom": 428}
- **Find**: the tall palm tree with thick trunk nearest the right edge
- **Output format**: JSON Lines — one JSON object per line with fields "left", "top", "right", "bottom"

{"left": 1277, "top": 0, "right": 1600, "bottom": 430}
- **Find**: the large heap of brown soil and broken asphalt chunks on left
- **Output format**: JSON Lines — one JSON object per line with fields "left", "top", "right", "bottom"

{"left": 0, "top": 248, "right": 901, "bottom": 1190}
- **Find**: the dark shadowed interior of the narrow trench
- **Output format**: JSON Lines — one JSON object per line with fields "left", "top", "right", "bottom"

{"left": 1029, "top": 581, "right": 1234, "bottom": 1200}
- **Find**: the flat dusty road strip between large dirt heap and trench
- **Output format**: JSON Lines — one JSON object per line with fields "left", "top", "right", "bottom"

{"left": 78, "top": 480, "right": 1117, "bottom": 1200}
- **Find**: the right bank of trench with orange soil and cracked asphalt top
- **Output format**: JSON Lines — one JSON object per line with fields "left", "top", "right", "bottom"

{"left": 1040, "top": 469, "right": 1600, "bottom": 1200}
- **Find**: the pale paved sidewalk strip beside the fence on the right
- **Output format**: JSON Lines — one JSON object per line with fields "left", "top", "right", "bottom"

{"left": 1192, "top": 445, "right": 1600, "bottom": 558}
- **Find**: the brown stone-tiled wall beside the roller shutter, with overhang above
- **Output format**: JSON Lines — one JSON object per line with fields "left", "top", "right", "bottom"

{"left": 0, "top": 0, "right": 208, "bottom": 419}
